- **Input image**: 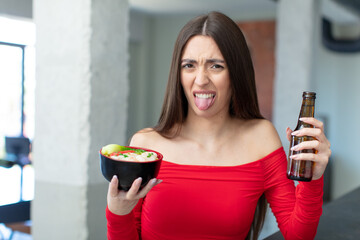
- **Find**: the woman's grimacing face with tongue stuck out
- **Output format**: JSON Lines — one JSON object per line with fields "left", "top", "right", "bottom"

{"left": 181, "top": 35, "right": 231, "bottom": 116}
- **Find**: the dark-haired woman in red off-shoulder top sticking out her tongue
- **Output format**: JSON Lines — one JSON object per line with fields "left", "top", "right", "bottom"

{"left": 106, "top": 12, "right": 330, "bottom": 240}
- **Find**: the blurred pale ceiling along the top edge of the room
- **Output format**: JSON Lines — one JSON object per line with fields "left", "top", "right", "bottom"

{"left": 129, "top": 0, "right": 360, "bottom": 25}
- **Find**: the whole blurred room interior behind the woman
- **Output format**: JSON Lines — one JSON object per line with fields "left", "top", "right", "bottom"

{"left": 0, "top": 0, "right": 360, "bottom": 239}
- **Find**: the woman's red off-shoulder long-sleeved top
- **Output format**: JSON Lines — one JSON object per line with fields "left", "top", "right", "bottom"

{"left": 106, "top": 148, "right": 323, "bottom": 240}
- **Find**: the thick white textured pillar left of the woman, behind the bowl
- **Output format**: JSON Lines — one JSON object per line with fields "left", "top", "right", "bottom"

{"left": 31, "top": 0, "right": 129, "bottom": 240}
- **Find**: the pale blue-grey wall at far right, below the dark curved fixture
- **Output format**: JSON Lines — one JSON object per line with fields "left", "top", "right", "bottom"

{"left": 314, "top": 27, "right": 360, "bottom": 198}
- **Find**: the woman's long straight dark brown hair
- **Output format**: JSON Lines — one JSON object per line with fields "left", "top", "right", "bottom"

{"left": 154, "top": 12, "right": 267, "bottom": 239}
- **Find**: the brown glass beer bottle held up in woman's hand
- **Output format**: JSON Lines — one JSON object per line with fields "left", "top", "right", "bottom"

{"left": 287, "top": 92, "right": 316, "bottom": 182}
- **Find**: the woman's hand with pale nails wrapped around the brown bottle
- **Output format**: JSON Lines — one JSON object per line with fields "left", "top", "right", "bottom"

{"left": 286, "top": 118, "right": 331, "bottom": 180}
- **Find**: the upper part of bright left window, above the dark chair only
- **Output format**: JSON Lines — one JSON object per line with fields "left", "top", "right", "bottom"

{"left": 0, "top": 17, "right": 35, "bottom": 157}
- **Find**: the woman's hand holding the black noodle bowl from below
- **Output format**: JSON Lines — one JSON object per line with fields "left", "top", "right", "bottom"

{"left": 107, "top": 175, "right": 162, "bottom": 215}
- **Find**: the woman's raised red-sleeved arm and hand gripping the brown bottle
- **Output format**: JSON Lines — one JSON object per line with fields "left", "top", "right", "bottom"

{"left": 265, "top": 118, "right": 331, "bottom": 239}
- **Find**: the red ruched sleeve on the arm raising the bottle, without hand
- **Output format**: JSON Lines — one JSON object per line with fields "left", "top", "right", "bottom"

{"left": 265, "top": 151, "right": 323, "bottom": 240}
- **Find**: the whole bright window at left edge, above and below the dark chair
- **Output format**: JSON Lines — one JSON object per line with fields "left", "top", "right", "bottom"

{"left": 0, "top": 16, "right": 35, "bottom": 205}
